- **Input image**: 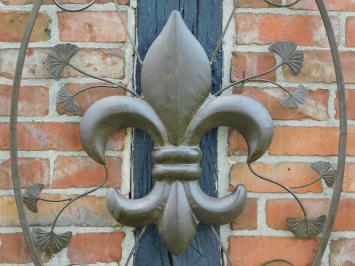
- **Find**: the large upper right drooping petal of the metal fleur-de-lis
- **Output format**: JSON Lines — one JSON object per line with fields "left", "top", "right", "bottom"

{"left": 186, "top": 95, "right": 273, "bottom": 163}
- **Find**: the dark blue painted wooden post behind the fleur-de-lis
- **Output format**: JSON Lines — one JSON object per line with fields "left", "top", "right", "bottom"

{"left": 132, "top": 0, "right": 222, "bottom": 266}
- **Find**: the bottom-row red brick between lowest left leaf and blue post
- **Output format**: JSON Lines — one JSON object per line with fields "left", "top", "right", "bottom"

{"left": 68, "top": 232, "right": 125, "bottom": 264}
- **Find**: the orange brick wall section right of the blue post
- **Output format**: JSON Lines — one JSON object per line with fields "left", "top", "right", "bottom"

{"left": 225, "top": 0, "right": 355, "bottom": 266}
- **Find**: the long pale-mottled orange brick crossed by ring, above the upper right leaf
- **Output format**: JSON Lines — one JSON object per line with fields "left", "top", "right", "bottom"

{"left": 235, "top": 13, "right": 339, "bottom": 47}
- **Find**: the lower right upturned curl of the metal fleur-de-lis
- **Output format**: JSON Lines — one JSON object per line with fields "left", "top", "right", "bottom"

{"left": 185, "top": 181, "right": 247, "bottom": 225}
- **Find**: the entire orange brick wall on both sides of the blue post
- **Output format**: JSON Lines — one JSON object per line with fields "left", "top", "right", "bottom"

{"left": 0, "top": 0, "right": 355, "bottom": 266}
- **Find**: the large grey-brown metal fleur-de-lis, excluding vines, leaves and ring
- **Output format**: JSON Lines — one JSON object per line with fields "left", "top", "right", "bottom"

{"left": 81, "top": 11, "right": 272, "bottom": 255}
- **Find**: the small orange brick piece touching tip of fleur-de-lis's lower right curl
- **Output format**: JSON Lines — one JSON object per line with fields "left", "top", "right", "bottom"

{"left": 231, "top": 198, "right": 258, "bottom": 230}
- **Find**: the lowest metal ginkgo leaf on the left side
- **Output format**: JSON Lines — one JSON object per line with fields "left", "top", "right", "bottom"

{"left": 32, "top": 228, "right": 73, "bottom": 254}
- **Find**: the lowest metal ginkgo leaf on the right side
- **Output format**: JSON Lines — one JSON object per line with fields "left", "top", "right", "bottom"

{"left": 287, "top": 215, "right": 327, "bottom": 238}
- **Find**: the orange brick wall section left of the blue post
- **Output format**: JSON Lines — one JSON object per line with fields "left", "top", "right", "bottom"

{"left": 0, "top": 0, "right": 135, "bottom": 265}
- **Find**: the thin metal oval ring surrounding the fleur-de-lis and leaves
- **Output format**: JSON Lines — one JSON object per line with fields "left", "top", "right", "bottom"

{"left": 10, "top": 0, "right": 347, "bottom": 266}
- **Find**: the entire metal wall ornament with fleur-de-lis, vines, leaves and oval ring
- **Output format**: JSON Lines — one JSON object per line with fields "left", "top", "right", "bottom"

{"left": 10, "top": 0, "right": 347, "bottom": 266}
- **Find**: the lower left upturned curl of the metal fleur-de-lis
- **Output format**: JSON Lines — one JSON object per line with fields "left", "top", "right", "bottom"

{"left": 106, "top": 182, "right": 169, "bottom": 227}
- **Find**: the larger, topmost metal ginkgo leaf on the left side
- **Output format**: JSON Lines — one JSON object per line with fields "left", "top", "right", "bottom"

{"left": 48, "top": 43, "right": 80, "bottom": 80}
